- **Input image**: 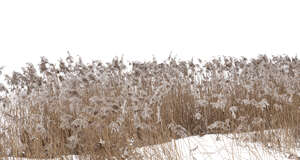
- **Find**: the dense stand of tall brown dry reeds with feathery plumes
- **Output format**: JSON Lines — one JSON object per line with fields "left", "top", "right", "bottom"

{"left": 0, "top": 55, "right": 300, "bottom": 159}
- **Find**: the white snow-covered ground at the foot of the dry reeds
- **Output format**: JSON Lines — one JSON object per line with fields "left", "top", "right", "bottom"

{"left": 4, "top": 133, "right": 300, "bottom": 160}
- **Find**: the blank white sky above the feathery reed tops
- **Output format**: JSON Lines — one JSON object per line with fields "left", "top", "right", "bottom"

{"left": 0, "top": 0, "right": 300, "bottom": 74}
